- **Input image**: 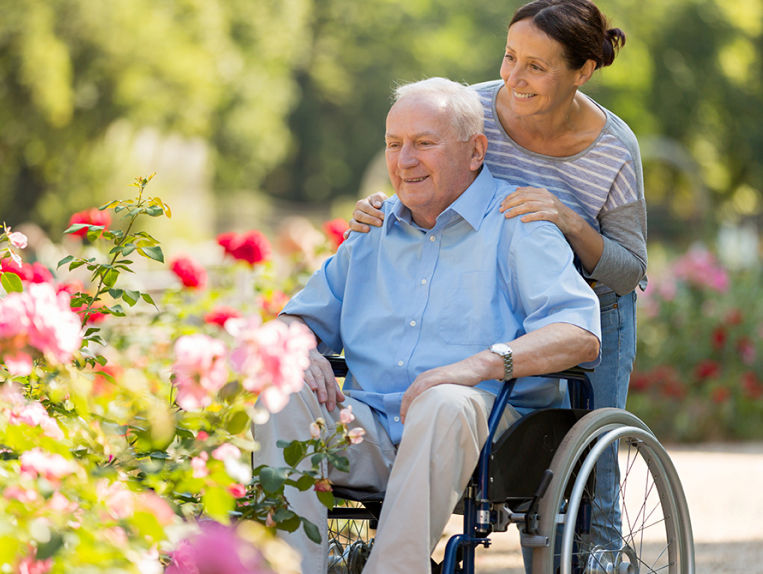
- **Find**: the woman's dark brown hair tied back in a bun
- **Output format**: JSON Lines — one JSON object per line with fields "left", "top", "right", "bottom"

{"left": 509, "top": 0, "right": 625, "bottom": 70}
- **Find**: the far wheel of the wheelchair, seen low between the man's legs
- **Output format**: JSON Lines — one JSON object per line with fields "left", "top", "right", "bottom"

{"left": 328, "top": 501, "right": 374, "bottom": 574}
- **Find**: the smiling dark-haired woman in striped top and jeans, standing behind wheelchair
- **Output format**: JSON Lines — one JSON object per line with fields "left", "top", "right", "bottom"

{"left": 351, "top": 0, "right": 647, "bottom": 564}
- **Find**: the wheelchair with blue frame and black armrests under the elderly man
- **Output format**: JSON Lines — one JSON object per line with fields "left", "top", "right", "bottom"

{"left": 328, "top": 356, "right": 694, "bottom": 574}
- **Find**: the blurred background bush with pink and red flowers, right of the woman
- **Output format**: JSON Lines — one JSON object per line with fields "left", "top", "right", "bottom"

{"left": 628, "top": 246, "right": 763, "bottom": 441}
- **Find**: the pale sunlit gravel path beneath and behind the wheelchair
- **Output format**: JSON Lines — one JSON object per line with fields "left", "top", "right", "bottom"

{"left": 438, "top": 443, "right": 763, "bottom": 574}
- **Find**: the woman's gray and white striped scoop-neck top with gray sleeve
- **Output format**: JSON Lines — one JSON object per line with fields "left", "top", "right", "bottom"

{"left": 473, "top": 80, "right": 647, "bottom": 295}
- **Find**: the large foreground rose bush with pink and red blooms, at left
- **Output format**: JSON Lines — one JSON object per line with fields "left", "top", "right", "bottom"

{"left": 0, "top": 178, "right": 362, "bottom": 574}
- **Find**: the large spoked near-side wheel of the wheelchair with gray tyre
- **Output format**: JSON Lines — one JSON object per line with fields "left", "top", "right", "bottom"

{"left": 533, "top": 409, "right": 694, "bottom": 574}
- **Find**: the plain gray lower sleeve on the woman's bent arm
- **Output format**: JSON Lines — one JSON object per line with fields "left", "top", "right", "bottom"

{"left": 585, "top": 199, "right": 647, "bottom": 295}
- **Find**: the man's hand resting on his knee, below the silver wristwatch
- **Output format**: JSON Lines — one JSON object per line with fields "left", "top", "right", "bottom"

{"left": 400, "top": 351, "right": 496, "bottom": 422}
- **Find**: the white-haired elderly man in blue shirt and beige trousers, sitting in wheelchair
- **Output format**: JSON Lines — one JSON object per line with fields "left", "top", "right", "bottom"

{"left": 255, "top": 78, "right": 600, "bottom": 574}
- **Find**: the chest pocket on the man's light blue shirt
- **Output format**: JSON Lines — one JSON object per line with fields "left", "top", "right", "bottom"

{"left": 440, "top": 271, "right": 498, "bottom": 348}
